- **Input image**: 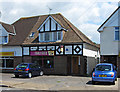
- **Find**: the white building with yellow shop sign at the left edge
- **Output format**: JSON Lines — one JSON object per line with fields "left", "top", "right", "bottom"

{"left": 0, "top": 22, "right": 22, "bottom": 72}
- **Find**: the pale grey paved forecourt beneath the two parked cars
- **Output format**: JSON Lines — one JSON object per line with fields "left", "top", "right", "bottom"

{"left": 0, "top": 73, "right": 120, "bottom": 90}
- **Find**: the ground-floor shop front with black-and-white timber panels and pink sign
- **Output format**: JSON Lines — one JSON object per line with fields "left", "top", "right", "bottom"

{"left": 23, "top": 44, "right": 85, "bottom": 75}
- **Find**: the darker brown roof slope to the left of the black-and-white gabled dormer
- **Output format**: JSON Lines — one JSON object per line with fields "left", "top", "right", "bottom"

{"left": 7, "top": 17, "right": 39, "bottom": 45}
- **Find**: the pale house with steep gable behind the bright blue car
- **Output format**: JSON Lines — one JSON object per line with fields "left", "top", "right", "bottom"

{"left": 98, "top": 6, "right": 120, "bottom": 76}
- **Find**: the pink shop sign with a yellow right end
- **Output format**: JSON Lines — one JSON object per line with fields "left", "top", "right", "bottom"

{"left": 30, "top": 51, "right": 54, "bottom": 56}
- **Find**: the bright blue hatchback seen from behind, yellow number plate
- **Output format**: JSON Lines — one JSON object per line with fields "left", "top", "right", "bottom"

{"left": 92, "top": 63, "right": 117, "bottom": 84}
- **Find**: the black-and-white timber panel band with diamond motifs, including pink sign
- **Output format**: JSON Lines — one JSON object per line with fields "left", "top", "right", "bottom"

{"left": 23, "top": 44, "right": 83, "bottom": 56}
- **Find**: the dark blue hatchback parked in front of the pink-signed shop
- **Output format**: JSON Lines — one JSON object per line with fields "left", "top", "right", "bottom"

{"left": 14, "top": 63, "right": 43, "bottom": 78}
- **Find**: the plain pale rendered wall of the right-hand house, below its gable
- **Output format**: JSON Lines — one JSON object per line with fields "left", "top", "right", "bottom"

{"left": 100, "top": 27, "right": 120, "bottom": 55}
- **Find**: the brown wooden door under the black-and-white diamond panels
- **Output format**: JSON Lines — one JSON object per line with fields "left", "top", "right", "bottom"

{"left": 72, "top": 57, "right": 78, "bottom": 75}
